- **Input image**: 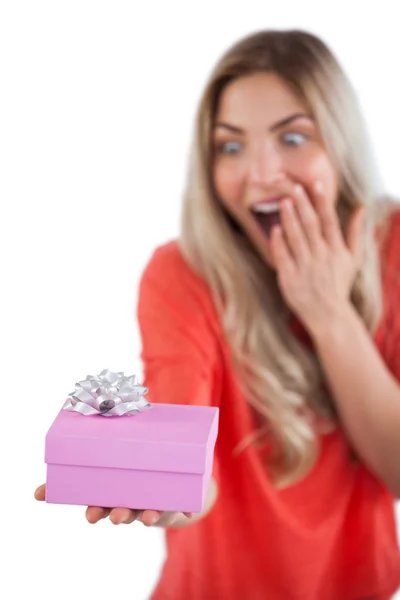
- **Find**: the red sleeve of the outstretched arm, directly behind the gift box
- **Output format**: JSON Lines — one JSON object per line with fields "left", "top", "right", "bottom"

{"left": 138, "top": 244, "right": 221, "bottom": 406}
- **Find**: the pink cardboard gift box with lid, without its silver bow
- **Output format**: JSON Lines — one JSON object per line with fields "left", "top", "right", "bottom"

{"left": 45, "top": 404, "right": 219, "bottom": 512}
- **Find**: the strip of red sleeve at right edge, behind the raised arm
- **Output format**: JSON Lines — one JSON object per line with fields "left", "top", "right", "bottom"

{"left": 382, "top": 209, "right": 400, "bottom": 382}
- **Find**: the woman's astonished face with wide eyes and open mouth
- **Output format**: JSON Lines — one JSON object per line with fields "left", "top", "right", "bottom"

{"left": 213, "top": 73, "right": 338, "bottom": 267}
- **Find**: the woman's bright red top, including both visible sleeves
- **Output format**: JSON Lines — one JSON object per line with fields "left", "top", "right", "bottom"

{"left": 138, "top": 211, "right": 400, "bottom": 600}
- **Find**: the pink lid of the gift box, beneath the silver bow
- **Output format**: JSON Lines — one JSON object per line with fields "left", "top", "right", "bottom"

{"left": 45, "top": 403, "right": 219, "bottom": 473}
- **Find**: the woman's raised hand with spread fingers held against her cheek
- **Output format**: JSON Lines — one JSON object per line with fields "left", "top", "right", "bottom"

{"left": 271, "top": 183, "right": 364, "bottom": 333}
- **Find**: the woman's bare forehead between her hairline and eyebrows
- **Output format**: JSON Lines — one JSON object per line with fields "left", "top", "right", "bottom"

{"left": 216, "top": 73, "right": 306, "bottom": 126}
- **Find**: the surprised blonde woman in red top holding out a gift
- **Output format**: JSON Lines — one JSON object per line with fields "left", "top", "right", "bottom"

{"left": 36, "top": 31, "right": 400, "bottom": 600}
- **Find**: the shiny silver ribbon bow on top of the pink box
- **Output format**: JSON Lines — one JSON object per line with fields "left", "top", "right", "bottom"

{"left": 63, "top": 369, "right": 151, "bottom": 417}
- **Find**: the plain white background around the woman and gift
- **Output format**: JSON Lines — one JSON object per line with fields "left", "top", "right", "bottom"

{"left": 0, "top": 0, "right": 400, "bottom": 600}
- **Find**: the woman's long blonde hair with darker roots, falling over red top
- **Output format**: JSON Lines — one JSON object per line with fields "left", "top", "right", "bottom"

{"left": 180, "top": 30, "right": 392, "bottom": 486}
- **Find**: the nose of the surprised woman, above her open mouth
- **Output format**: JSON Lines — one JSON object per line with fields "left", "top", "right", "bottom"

{"left": 248, "top": 144, "right": 286, "bottom": 186}
